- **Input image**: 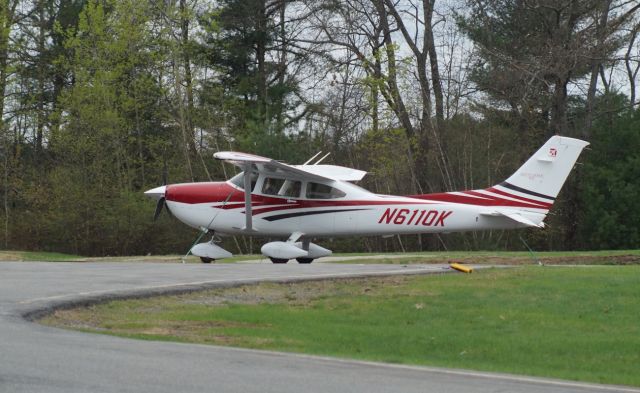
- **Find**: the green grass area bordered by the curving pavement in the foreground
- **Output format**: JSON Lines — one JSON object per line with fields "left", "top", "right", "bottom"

{"left": 45, "top": 266, "right": 640, "bottom": 386}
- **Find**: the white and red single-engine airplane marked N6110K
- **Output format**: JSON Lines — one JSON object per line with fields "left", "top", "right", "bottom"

{"left": 145, "top": 136, "right": 588, "bottom": 263}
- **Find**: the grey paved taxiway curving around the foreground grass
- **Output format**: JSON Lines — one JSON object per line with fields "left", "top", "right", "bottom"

{"left": 0, "top": 262, "right": 640, "bottom": 393}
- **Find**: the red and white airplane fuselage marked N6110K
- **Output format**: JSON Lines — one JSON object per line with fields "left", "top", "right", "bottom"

{"left": 166, "top": 182, "right": 546, "bottom": 237}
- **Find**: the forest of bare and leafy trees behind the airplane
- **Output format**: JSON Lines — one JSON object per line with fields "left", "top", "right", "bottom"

{"left": 0, "top": 0, "right": 640, "bottom": 255}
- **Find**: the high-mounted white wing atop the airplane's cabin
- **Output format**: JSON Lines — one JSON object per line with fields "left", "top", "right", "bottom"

{"left": 213, "top": 151, "right": 367, "bottom": 182}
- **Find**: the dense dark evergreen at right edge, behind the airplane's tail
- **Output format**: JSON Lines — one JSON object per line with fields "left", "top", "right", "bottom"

{"left": 578, "top": 94, "right": 640, "bottom": 249}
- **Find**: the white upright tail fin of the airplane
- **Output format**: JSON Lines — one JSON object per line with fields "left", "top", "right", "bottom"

{"left": 498, "top": 135, "right": 589, "bottom": 203}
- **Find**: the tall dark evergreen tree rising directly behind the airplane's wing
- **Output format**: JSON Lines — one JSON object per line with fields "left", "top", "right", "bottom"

{"left": 200, "top": 0, "right": 296, "bottom": 156}
